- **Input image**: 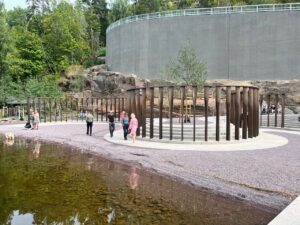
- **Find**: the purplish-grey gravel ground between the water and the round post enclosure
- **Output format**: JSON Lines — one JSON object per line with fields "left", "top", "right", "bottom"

{"left": 0, "top": 123, "right": 300, "bottom": 211}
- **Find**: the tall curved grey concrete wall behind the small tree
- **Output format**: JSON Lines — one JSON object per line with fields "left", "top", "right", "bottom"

{"left": 106, "top": 4, "right": 300, "bottom": 80}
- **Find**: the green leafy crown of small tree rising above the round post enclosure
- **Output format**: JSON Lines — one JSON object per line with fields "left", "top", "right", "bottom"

{"left": 163, "top": 45, "right": 207, "bottom": 87}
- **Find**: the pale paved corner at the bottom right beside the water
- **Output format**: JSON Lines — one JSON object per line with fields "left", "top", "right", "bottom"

{"left": 268, "top": 196, "right": 300, "bottom": 225}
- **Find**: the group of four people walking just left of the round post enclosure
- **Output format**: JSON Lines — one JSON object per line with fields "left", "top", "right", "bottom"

{"left": 86, "top": 111, "right": 138, "bottom": 143}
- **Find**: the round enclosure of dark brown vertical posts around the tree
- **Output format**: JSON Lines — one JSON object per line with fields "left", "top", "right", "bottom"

{"left": 126, "top": 86, "right": 259, "bottom": 141}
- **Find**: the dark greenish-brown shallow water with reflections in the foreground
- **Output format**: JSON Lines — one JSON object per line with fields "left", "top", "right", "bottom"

{"left": 0, "top": 136, "right": 275, "bottom": 225}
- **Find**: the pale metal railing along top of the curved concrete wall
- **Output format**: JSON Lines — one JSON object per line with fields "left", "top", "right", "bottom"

{"left": 106, "top": 3, "right": 300, "bottom": 32}
